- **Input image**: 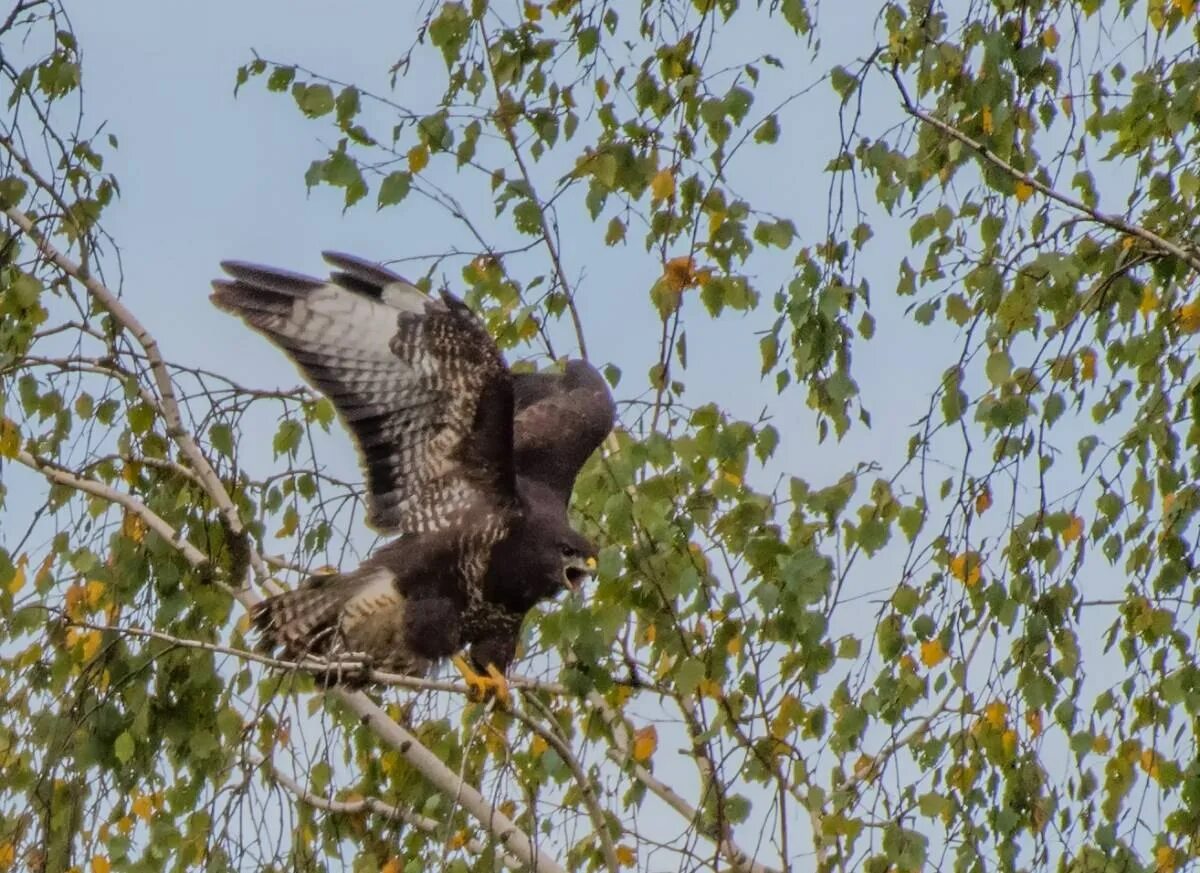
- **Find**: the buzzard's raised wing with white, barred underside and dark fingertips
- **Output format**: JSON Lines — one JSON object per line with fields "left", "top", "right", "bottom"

{"left": 212, "top": 247, "right": 515, "bottom": 532}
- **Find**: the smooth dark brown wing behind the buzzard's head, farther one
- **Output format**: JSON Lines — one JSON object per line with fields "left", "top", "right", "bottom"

{"left": 512, "top": 360, "right": 617, "bottom": 506}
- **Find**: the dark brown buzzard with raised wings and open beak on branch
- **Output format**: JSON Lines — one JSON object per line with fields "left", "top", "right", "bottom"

{"left": 212, "top": 252, "right": 616, "bottom": 694}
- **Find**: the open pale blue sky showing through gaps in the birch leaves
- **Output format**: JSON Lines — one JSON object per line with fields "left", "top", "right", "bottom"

{"left": 2, "top": 0, "right": 1171, "bottom": 868}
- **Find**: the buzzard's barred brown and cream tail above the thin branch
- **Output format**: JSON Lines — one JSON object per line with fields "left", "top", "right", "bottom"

{"left": 250, "top": 573, "right": 359, "bottom": 660}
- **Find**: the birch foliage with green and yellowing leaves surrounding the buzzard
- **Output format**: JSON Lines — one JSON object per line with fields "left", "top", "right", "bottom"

{"left": 7, "top": 0, "right": 1200, "bottom": 873}
